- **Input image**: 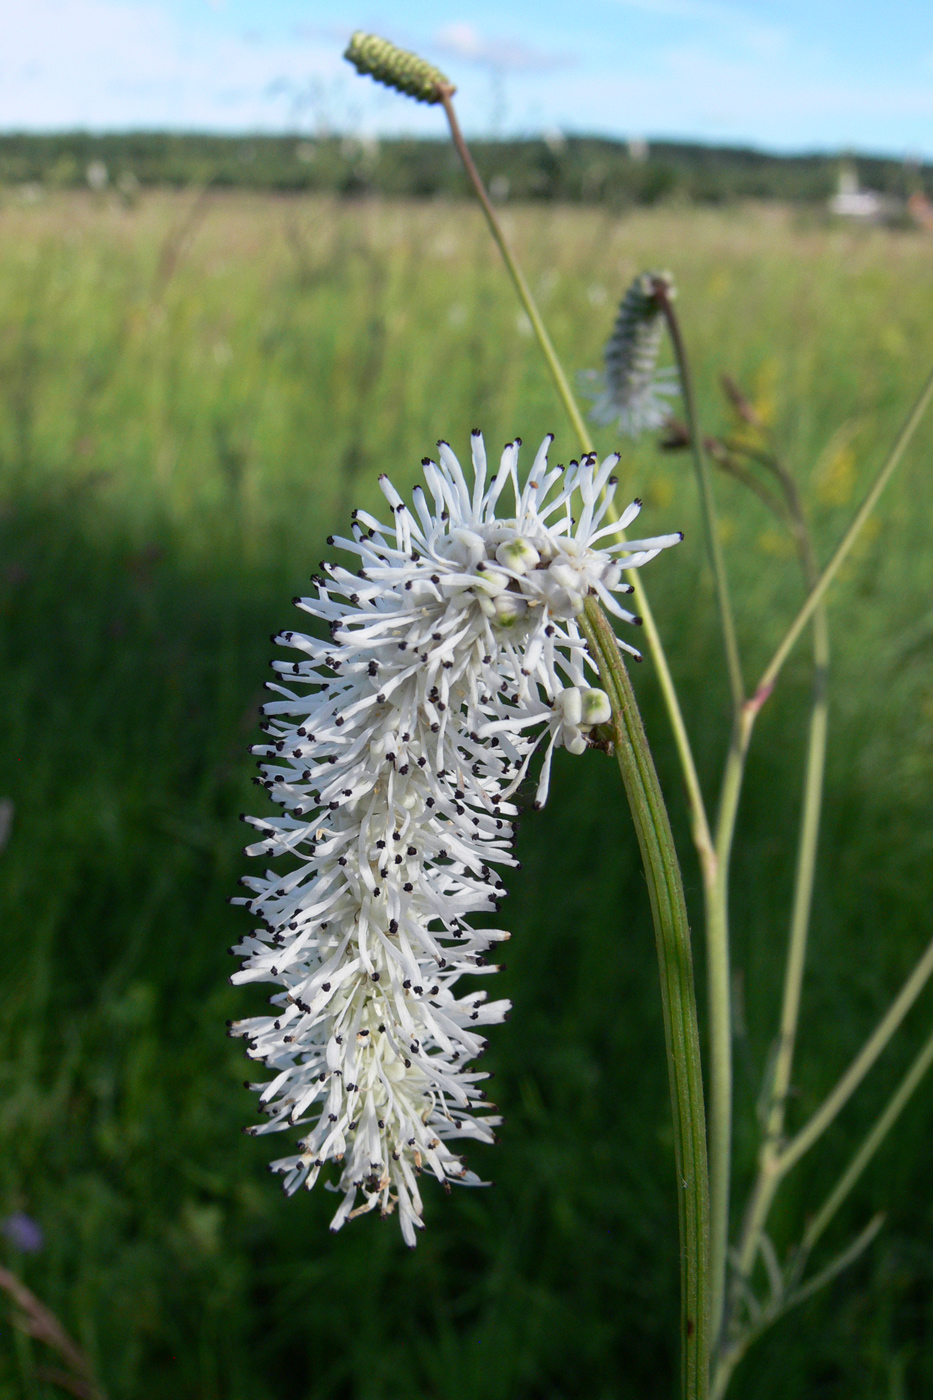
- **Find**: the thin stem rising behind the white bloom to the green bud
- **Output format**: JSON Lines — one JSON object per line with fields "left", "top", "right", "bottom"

{"left": 438, "top": 87, "right": 714, "bottom": 871}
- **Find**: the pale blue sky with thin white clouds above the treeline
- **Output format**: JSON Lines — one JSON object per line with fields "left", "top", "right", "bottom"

{"left": 0, "top": 0, "right": 933, "bottom": 158}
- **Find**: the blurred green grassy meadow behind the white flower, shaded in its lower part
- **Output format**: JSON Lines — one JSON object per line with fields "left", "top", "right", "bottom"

{"left": 0, "top": 190, "right": 933, "bottom": 1400}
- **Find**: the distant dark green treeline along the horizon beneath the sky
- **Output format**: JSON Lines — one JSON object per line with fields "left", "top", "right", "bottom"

{"left": 0, "top": 132, "right": 933, "bottom": 206}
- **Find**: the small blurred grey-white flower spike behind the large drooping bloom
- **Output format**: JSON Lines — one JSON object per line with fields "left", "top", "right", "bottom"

{"left": 581, "top": 272, "right": 678, "bottom": 437}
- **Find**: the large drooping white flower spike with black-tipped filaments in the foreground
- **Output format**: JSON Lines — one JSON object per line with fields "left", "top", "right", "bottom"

{"left": 225, "top": 433, "right": 681, "bottom": 1245}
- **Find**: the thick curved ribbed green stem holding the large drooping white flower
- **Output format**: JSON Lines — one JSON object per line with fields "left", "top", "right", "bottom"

{"left": 580, "top": 598, "right": 710, "bottom": 1400}
